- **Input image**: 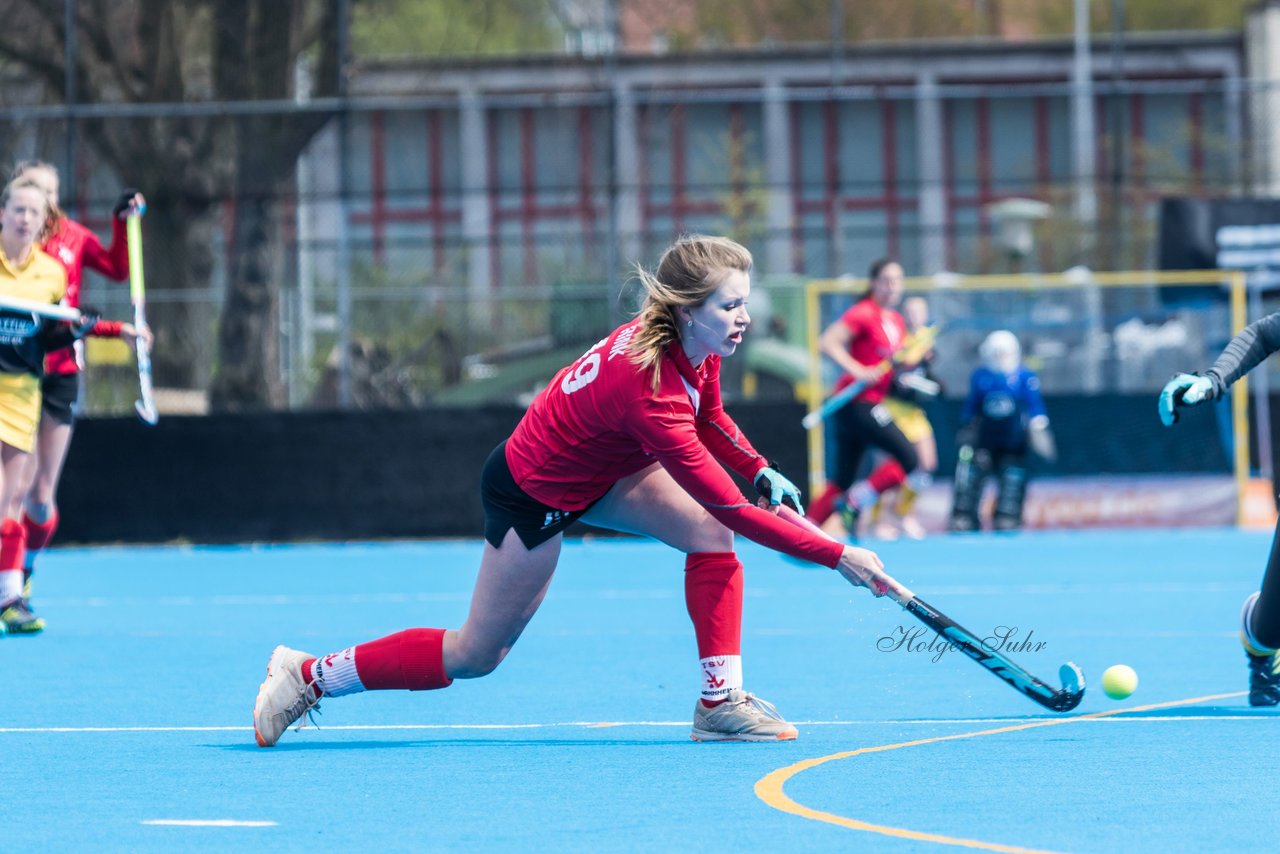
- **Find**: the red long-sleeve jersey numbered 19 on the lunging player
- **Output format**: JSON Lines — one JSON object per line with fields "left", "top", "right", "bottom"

{"left": 507, "top": 321, "right": 844, "bottom": 567}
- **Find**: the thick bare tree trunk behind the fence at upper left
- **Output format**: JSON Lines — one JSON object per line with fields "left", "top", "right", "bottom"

{"left": 0, "top": 0, "right": 342, "bottom": 410}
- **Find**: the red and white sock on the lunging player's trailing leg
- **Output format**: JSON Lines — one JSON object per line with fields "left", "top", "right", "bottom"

{"left": 302, "top": 629, "right": 453, "bottom": 697}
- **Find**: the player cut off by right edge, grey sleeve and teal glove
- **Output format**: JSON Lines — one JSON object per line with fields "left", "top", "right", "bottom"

{"left": 1158, "top": 312, "right": 1280, "bottom": 705}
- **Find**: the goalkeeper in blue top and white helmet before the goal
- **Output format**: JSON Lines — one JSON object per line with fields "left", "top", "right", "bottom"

{"left": 948, "top": 329, "right": 1056, "bottom": 533}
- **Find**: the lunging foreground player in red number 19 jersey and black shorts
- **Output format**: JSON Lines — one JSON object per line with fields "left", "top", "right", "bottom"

{"left": 253, "top": 236, "right": 892, "bottom": 746}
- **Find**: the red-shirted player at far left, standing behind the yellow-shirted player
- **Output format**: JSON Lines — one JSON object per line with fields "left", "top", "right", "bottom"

{"left": 13, "top": 160, "right": 151, "bottom": 608}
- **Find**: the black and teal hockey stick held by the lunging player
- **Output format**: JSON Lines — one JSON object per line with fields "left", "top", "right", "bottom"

{"left": 778, "top": 506, "right": 1084, "bottom": 712}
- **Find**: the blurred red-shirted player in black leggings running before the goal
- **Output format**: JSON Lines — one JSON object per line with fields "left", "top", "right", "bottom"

{"left": 809, "top": 259, "right": 919, "bottom": 538}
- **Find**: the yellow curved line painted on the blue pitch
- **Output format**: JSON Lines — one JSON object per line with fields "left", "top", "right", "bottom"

{"left": 755, "top": 691, "right": 1245, "bottom": 854}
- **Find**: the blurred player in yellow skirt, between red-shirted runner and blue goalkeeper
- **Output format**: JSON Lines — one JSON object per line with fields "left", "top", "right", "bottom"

{"left": 868, "top": 297, "right": 942, "bottom": 539}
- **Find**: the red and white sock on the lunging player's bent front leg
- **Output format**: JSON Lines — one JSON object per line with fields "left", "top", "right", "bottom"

{"left": 685, "top": 552, "right": 742, "bottom": 703}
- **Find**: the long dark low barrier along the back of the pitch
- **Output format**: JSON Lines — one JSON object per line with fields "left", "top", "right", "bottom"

{"left": 59, "top": 394, "right": 1228, "bottom": 544}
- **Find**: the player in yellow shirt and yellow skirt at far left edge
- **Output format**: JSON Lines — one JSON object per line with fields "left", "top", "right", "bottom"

{"left": 0, "top": 178, "right": 97, "bottom": 634}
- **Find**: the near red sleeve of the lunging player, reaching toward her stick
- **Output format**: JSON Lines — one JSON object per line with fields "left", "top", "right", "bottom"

{"left": 627, "top": 397, "right": 844, "bottom": 567}
